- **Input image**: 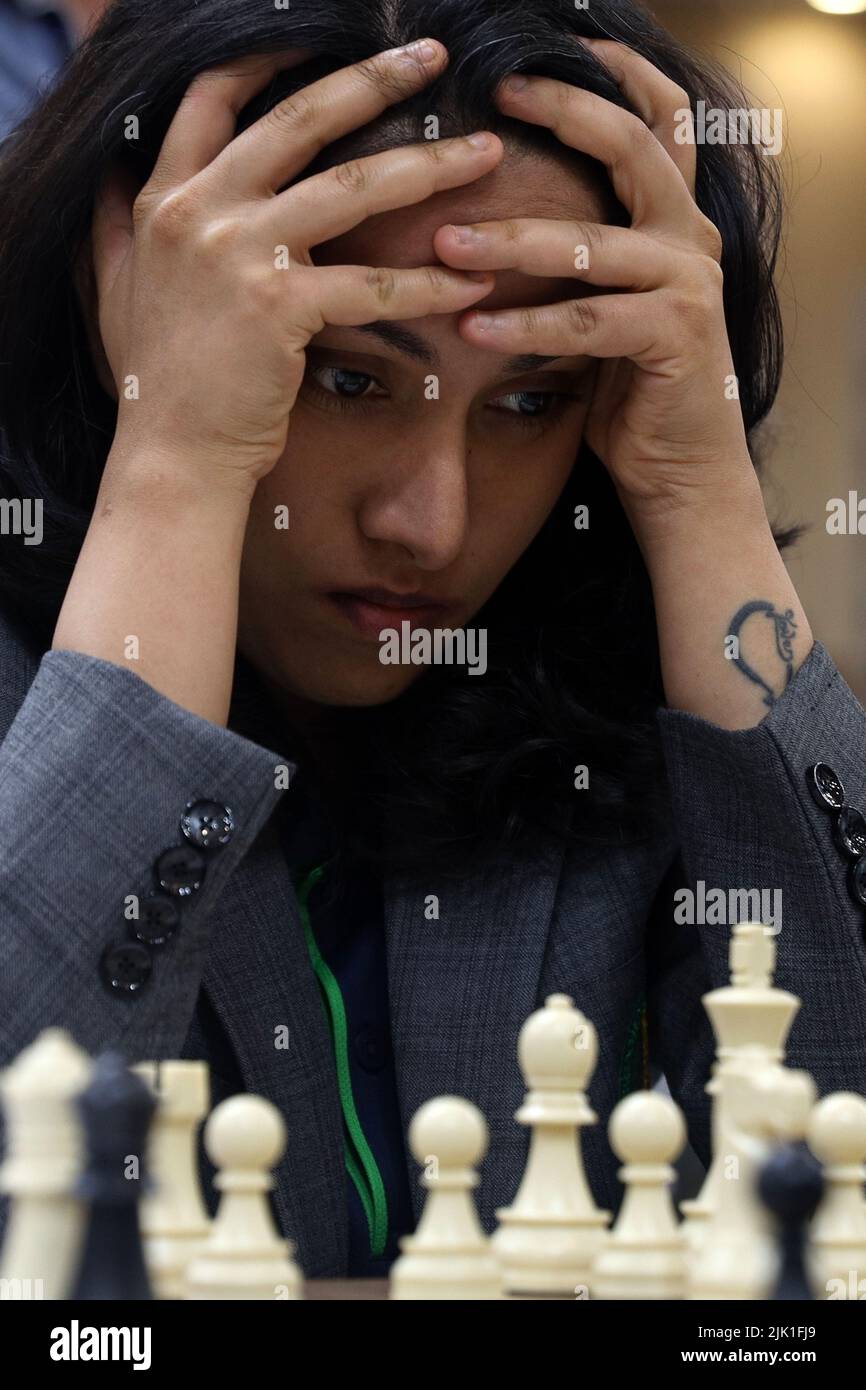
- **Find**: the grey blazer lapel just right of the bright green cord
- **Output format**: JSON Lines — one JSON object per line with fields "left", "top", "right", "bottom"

{"left": 385, "top": 822, "right": 563, "bottom": 1230}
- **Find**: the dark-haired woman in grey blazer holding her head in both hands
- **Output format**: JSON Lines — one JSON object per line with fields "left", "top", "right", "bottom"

{"left": 0, "top": 0, "right": 866, "bottom": 1275}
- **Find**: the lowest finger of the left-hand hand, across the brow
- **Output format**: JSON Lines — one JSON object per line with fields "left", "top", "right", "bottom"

{"left": 291, "top": 265, "right": 495, "bottom": 342}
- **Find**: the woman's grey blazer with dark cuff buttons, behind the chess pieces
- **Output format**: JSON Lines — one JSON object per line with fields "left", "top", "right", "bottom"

{"left": 0, "top": 603, "right": 866, "bottom": 1276}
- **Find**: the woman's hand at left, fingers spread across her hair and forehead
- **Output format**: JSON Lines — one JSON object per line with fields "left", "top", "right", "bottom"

{"left": 92, "top": 42, "right": 502, "bottom": 492}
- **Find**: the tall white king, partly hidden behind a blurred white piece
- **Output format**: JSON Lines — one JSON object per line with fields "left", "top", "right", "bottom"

{"left": 681, "top": 922, "right": 799, "bottom": 1248}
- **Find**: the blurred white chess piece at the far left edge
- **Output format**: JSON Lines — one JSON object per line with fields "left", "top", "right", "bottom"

{"left": 0, "top": 1029, "right": 92, "bottom": 1298}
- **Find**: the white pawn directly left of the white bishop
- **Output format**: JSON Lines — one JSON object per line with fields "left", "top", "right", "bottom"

{"left": 389, "top": 1095, "right": 502, "bottom": 1300}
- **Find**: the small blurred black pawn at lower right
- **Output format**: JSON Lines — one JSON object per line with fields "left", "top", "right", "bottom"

{"left": 758, "top": 1143, "right": 824, "bottom": 1301}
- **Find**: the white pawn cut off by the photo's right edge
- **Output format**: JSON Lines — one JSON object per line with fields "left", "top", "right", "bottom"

{"left": 806, "top": 1091, "right": 866, "bottom": 1300}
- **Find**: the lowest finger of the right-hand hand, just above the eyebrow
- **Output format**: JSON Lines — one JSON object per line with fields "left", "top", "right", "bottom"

{"left": 459, "top": 291, "right": 671, "bottom": 363}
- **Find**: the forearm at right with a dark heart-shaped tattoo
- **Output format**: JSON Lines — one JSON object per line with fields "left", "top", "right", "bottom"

{"left": 638, "top": 480, "right": 813, "bottom": 730}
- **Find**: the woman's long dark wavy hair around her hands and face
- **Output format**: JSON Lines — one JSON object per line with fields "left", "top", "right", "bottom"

{"left": 0, "top": 0, "right": 799, "bottom": 873}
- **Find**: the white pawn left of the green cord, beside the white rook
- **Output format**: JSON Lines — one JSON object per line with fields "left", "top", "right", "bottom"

{"left": 185, "top": 1095, "right": 303, "bottom": 1300}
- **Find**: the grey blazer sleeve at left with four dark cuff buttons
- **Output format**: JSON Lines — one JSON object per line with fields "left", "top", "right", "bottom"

{"left": 0, "top": 625, "right": 295, "bottom": 1065}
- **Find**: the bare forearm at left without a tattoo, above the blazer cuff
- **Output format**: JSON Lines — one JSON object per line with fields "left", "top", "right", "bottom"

{"left": 51, "top": 457, "right": 252, "bottom": 726}
